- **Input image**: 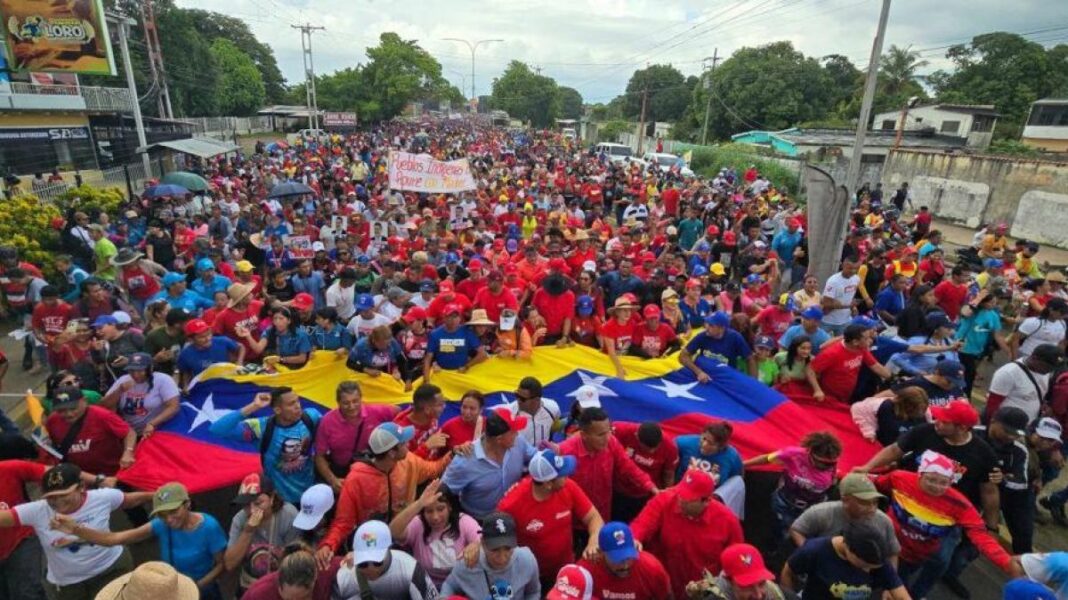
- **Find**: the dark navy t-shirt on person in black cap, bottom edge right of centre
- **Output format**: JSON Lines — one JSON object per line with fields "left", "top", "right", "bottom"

{"left": 787, "top": 537, "right": 901, "bottom": 600}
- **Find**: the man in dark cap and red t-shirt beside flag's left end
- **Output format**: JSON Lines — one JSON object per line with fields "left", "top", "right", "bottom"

{"left": 45, "top": 385, "right": 137, "bottom": 477}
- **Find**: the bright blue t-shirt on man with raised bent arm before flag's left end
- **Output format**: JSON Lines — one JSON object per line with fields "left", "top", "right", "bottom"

{"left": 211, "top": 408, "right": 323, "bottom": 499}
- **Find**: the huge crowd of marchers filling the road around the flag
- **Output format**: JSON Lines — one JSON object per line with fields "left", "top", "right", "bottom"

{"left": 0, "top": 121, "right": 1068, "bottom": 600}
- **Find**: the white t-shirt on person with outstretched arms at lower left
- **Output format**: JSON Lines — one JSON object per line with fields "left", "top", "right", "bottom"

{"left": 15, "top": 490, "right": 125, "bottom": 586}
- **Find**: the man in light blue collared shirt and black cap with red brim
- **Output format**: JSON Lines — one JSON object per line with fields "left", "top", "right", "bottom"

{"left": 441, "top": 408, "right": 536, "bottom": 519}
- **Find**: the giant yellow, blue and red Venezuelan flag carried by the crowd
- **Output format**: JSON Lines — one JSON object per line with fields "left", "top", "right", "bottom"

{"left": 120, "top": 347, "right": 878, "bottom": 492}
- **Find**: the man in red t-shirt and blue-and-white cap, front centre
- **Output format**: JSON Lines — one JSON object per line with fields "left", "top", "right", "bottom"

{"left": 497, "top": 449, "right": 604, "bottom": 587}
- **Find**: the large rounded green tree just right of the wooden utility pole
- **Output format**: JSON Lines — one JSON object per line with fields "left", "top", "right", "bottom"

{"left": 676, "top": 42, "right": 834, "bottom": 140}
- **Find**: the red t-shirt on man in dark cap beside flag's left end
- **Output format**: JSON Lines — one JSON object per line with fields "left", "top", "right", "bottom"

{"left": 45, "top": 406, "right": 130, "bottom": 476}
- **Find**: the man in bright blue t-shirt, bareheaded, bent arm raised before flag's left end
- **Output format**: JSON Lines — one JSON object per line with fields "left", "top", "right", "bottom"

{"left": 211, "top": 388, "right": 323, "bottom": 505}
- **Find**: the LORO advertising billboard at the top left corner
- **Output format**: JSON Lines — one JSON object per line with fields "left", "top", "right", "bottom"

{"left": 0, "top": 0, "right": 115, "bottom": 75}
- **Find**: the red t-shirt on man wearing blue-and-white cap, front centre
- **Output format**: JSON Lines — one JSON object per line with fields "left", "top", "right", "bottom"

{"left": 497, "top": 477, "right": 594, "bottom": 579}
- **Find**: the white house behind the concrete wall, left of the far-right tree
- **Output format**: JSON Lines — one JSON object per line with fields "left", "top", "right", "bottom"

{"left": 871, "top": 104, "right": 1001, "bottom": 149}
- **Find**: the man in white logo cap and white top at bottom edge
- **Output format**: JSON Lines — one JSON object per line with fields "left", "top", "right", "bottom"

{"left": 336, "top": 521, "right": 438, "bottom": 600}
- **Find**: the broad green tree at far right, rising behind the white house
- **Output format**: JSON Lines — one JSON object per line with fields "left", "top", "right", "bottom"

{"left": 929, "top": 32, "right": 1055, "bottom": 138}
